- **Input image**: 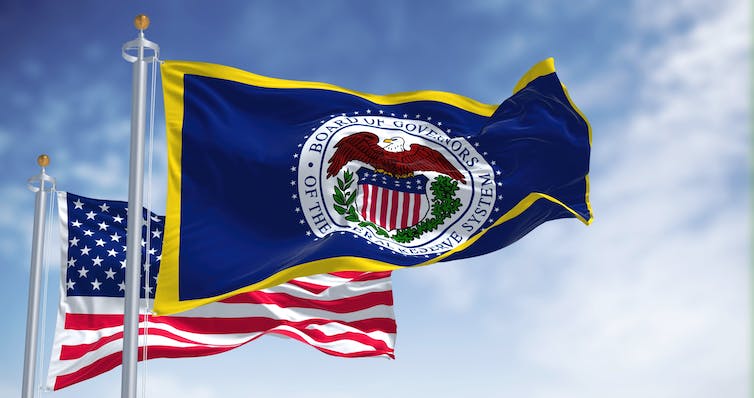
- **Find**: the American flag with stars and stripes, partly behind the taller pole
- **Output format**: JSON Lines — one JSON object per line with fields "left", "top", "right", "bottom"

{"left": 47, "top": 192, "right": 396, "bottom": 390}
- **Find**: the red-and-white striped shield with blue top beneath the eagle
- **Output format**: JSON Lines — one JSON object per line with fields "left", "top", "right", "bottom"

{"left": 356, "top": 167, "right": 430, "bottom": 231}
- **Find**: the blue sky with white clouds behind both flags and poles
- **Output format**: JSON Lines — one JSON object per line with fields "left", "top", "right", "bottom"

{"left": 0, "top": 0, "right": 752, "bottom": 398}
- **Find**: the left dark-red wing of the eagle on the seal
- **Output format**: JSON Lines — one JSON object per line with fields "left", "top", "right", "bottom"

{"left": 327, "top": 132, "right": 386, "bottom": 178}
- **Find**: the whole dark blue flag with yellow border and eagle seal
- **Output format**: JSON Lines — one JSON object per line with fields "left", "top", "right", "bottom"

{"left": 155, "top": 59, "right": 592, "bottom": 314}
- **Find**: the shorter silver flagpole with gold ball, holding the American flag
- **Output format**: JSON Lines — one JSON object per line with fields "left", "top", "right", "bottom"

{"left": 21, "top": 155, "right": 55, "bottom": 398}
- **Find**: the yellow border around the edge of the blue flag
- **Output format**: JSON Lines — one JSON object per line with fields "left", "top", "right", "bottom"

{"left": 154, "top": 58, "right": 594, "bottom": 315}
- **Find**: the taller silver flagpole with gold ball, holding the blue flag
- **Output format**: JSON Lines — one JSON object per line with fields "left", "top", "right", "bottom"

{"left": 120, "top": 15, "right": 159, "bottom": 398}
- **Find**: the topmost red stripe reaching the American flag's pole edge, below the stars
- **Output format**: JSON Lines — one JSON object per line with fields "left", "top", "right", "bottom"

{"left": 65, "top": 314, "right": 395, "bottom": 334}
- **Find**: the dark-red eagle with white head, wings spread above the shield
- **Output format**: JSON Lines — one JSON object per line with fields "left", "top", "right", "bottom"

{"left": 327, "top": 131, "right": 466, "bottom": 184}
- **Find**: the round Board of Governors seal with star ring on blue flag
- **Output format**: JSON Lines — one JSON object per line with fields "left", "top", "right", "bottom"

{"left": 291, "top": 114, "right": 502, "bottom": 257}
